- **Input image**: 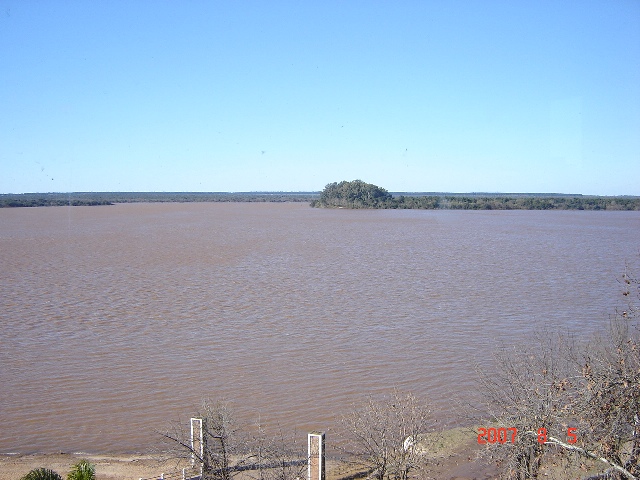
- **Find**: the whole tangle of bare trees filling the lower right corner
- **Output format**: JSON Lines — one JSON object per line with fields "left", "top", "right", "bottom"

{"left": 478, "top": 266, "right": 640, "bottom": 480}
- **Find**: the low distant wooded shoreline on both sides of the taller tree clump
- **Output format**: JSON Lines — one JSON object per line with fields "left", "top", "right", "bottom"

{"left": 0, "top": 192, "right": 640, "bottom": 211}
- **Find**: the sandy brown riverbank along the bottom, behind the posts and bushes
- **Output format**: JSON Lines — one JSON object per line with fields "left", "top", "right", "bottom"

{"left": 0, "top": 429, "right": 496, "bottom": 480}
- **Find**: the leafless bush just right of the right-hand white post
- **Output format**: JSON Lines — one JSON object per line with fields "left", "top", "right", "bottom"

{"left": 342, "top": 391, "right": 431, "bottom": 480}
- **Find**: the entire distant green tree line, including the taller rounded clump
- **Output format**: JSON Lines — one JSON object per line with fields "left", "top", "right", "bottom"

{"left": 0, "top": 185, "right": 640, "bottom": 211}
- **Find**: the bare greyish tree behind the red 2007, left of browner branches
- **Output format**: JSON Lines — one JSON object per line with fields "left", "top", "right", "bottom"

{"left": 478, "top": 337, "right": 576, "bottom": 480}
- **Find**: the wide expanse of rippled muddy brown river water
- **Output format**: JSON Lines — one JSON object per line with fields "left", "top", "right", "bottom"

{"left": 0, "top": 203, "right": 640, "bottom": 453}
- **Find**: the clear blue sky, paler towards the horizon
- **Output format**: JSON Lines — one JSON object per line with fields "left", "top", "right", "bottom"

{"left": 0, "top": 0, "right": 640, "bottom": 195}
